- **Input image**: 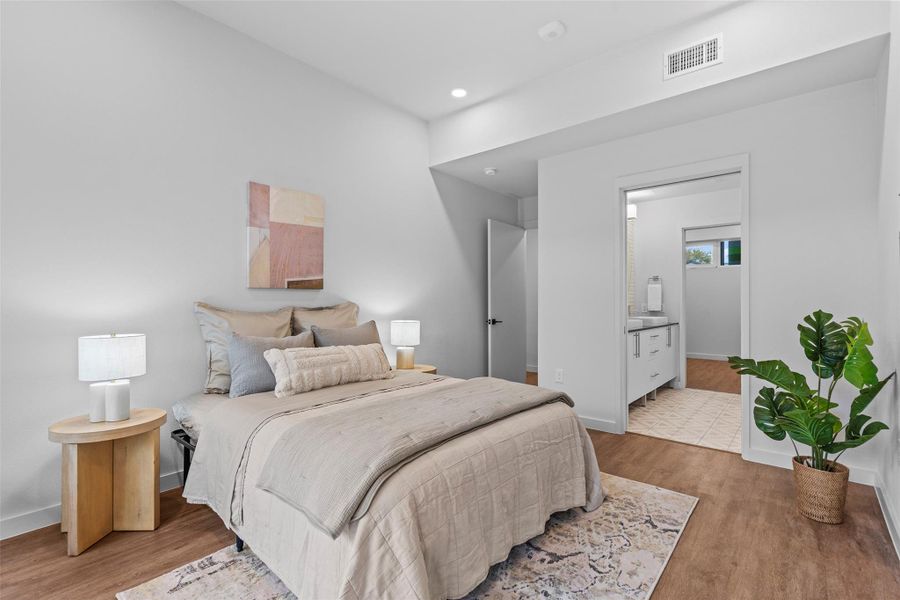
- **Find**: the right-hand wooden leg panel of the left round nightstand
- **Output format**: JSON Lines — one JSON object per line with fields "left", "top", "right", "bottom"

{"left": 113, "top": 429, "right": 159, "bottom": 531}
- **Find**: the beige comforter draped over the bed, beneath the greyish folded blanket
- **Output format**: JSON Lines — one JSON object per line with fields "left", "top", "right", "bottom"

{"left": 185, "top": 374, "right": 603, "bottom": 599}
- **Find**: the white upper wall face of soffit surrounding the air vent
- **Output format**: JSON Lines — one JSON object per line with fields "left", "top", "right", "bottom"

{"left": 429, "top": 1, "right": 890, "bottom": 165}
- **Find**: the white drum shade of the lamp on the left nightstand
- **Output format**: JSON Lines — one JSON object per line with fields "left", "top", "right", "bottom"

{"left": 78, "top": 333, "right": 147, "bottom": 381}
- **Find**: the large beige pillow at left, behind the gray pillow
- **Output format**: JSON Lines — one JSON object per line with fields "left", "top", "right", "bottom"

{"left": 194, "top": 302, "right": 294, "bottom": 394}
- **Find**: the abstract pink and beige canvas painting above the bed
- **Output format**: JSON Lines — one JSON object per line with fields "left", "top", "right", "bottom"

{"left": 247, "top": 181, "right": 325, "bottom": 290}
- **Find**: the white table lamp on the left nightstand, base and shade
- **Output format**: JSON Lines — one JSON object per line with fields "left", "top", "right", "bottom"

{"left": 78, "top": 333, "right": 147, "bottom": 423}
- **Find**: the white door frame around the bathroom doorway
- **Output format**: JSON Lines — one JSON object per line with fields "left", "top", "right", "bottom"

{"left": 613, "top": 153, "right": 753, "bottom": 458}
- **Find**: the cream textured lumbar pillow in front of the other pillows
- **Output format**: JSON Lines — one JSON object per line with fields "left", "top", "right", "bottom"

{"left": 264, "top": 344, "right": 394, "bottom": 398}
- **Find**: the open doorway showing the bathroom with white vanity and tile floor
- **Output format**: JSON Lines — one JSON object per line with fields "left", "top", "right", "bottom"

{"left": 625, "top": 172, "right": 742, "bottom": 453}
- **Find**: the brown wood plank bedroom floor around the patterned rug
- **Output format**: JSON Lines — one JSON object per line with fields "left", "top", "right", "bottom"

{"left": 0, "top": 431, "right": 900, "bottom": 600}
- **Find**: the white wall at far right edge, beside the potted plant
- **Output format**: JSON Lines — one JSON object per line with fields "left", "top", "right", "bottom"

{"left": 872, "top": 3, "right": 900, "bottom": 553}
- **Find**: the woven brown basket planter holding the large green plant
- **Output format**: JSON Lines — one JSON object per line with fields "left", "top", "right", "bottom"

{"left": 793, "top": 456, "right": 850, "bottom": 523}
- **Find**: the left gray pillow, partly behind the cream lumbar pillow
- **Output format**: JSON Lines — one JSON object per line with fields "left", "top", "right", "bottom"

{"left": 228, "top": 331, "right": 315, "bottom": 398}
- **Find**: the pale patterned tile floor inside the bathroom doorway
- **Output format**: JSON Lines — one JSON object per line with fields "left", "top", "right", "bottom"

{"left": 628, "top": 388, "right": 741, "bottom": 453}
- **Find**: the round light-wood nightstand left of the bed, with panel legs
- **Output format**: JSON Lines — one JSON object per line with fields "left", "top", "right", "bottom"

{"left": 47, "top": 408, "right": 167, "bottom": 556}
